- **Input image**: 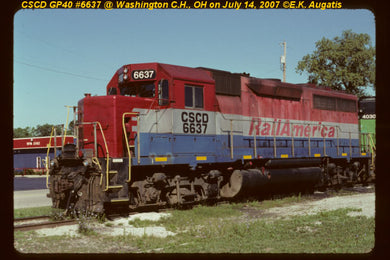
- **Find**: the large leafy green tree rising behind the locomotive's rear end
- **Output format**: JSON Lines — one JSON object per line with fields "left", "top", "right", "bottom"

{"left": 296, "top": 30, "right": 375, "bottom": 96}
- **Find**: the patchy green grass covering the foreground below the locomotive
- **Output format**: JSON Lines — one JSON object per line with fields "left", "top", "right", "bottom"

{"left": 15, "top": 195, "right": 375, "bottom": 253}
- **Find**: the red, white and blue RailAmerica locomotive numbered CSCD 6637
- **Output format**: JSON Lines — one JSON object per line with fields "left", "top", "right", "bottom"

{"left": 49, "top": 63, "right": 371, "bottom": 212}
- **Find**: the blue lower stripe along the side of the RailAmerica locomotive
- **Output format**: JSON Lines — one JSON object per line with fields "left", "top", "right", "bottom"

{"left": 132, "top": 133, "right": 368, "bottom": 167}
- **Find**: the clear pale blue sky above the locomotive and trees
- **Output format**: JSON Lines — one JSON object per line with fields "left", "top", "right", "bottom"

{"left": 13, "top": 9, "right": 376, "bottom": 128}
